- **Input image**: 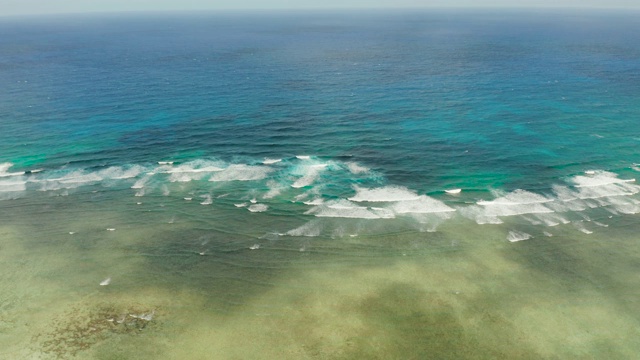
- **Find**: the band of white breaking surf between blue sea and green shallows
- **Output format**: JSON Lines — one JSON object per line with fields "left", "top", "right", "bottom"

{"left": 0, "top": 157, "right": 640, "bottom": 239}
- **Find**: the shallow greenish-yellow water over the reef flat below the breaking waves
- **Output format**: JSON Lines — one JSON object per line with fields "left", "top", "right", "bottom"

{"left": 0, "top": 192, "right": 640, "bottom": 359}
